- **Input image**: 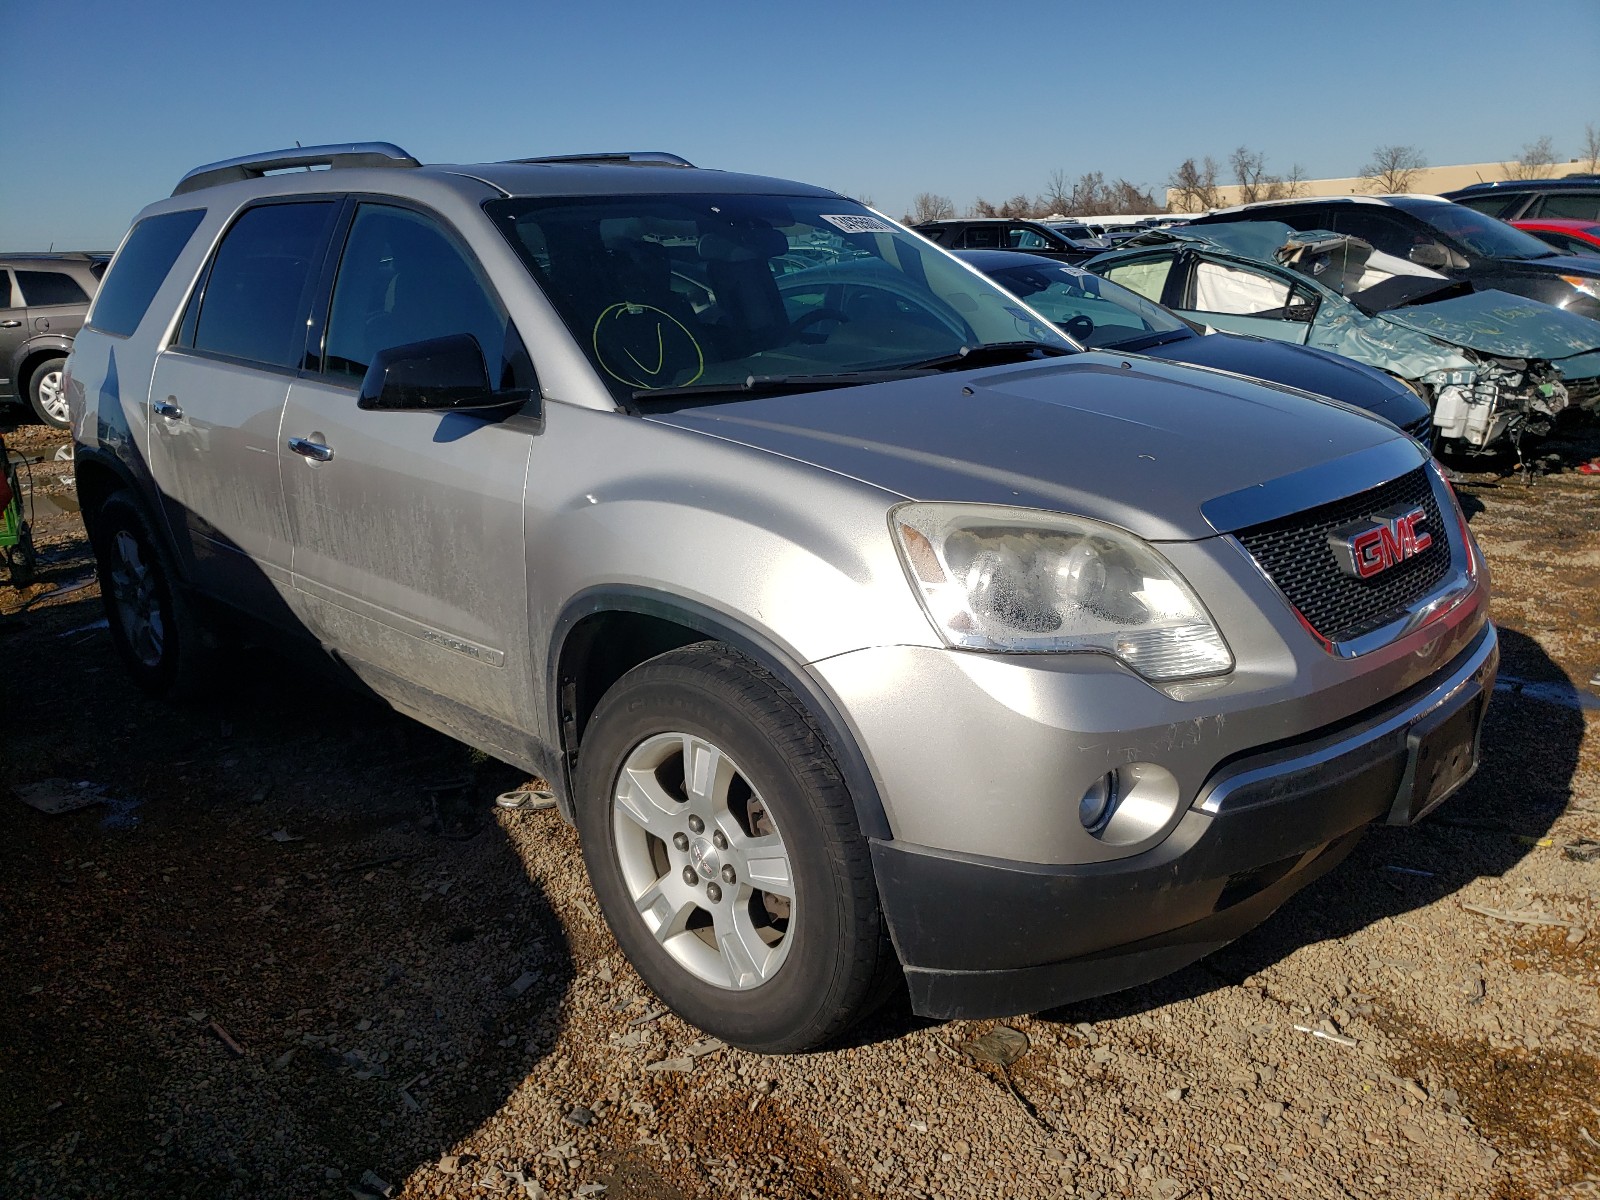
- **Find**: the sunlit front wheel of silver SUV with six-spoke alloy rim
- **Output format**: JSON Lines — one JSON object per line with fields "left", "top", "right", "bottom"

{"left": 578, "top": 642, "right": 894, "bottom": 1053}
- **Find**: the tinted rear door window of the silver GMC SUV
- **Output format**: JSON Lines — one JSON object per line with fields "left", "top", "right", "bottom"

{"left": 194, "top": 200, "right": 338, "bottom": 368}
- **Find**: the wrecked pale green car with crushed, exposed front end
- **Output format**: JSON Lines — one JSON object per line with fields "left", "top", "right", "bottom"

{"left": 1083, "top": 221, "right": 1600, "bottom": 458}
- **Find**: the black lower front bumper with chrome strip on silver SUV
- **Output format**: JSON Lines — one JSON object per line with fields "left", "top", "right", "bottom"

{"left": 872, "top": 624, "right": 1499, "bottom": 1018}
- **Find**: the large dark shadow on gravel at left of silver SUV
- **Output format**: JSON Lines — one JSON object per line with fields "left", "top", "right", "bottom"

{"left": 0, "top": 531, "right": 573, "bottom": 1198}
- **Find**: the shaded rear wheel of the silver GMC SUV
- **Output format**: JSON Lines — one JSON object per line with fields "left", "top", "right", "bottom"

{"left": 88, "top": 491, "right": 213, "bottom": 699}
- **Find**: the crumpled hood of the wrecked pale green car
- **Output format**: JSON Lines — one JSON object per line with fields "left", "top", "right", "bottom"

{"left": 1378, "top": 290, "right": 1600, "bottom": 362}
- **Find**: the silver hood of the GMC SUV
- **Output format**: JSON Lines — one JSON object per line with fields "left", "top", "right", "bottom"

{"left": 648, "top": 352, "right": 1422, "bottom": 541}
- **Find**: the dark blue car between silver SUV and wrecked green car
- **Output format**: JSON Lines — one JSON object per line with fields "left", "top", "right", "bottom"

{"left": 955, "top": 250, "right": 1434, "bottom": 446}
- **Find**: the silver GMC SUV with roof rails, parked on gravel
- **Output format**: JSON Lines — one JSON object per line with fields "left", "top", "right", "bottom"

{"left": 66, "top": 144, "right": 1498, "bottom": 1051}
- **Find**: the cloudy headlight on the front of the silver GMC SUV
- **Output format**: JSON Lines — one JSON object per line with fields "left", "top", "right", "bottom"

{"left": 890, "top": 504, "right": 1234, "bottom": 680}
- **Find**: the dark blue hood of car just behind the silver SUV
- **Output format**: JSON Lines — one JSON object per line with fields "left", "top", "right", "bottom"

{"left": 1141, "top": 333, "right": 1429, "bottom": 427}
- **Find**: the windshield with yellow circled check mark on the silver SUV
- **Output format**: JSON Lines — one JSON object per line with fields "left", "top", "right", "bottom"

{"left": 488, "top": 195, "right": 1075, "bottom": 398}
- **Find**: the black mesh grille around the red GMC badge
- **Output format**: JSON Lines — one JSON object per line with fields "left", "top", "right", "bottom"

{"left": 1235, "top": 467, "right": 1450, "bottom": 642}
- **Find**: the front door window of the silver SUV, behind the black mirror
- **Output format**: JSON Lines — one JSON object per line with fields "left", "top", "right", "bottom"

{"left": 323, "top": 205, "right": 515, "bottom": 387}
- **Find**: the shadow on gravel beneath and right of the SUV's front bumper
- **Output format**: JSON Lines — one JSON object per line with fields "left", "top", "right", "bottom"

{"left": 1038, "top": 629, "right": 1584, "bottom": 1024}
